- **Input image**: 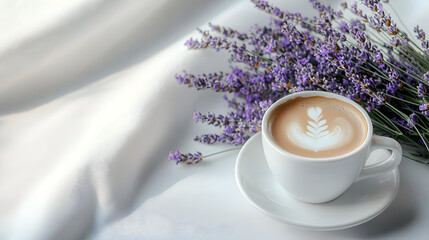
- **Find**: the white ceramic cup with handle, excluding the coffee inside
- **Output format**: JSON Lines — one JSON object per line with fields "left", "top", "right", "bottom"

{"left": 262, "top": 91, "right": 402, "bottom": 203}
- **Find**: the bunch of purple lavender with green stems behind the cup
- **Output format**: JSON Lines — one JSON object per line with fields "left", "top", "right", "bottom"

{"left": 169, "top": 0, "right": 429, "bottom": 165}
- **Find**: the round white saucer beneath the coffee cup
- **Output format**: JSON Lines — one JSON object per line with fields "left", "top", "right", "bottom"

{"left": 235, "top": 133, "right": 399, "bottom": 230}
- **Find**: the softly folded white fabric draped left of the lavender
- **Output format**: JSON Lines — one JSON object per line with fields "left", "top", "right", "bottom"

{"left": 0, "top": 0, "right": 234, "bottom": 239}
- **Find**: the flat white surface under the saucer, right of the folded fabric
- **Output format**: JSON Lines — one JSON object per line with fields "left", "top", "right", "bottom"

{"left": 97, "top": 140, "right": 429, "bottom": 239}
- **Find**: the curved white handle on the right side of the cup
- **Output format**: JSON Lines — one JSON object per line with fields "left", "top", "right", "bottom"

{"left": 356, "top": 135, "right": 402, "bottom": 181}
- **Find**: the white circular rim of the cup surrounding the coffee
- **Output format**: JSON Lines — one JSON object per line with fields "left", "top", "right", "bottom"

{"left": 262, "top": 91, "right": 373, "bottom": 162}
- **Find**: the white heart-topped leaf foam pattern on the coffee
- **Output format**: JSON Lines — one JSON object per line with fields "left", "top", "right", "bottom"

{"left": 287, "top": 107, "right": 353, "bottom": 152}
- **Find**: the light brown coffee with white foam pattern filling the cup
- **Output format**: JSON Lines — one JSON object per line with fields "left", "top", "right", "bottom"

{"left": 268, "top": 96, "right": 368, "bottom": 158}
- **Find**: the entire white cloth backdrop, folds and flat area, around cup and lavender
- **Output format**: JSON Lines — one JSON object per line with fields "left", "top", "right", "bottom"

{"left": 0, "top": 0, "right": 429, "bottom": 240}
